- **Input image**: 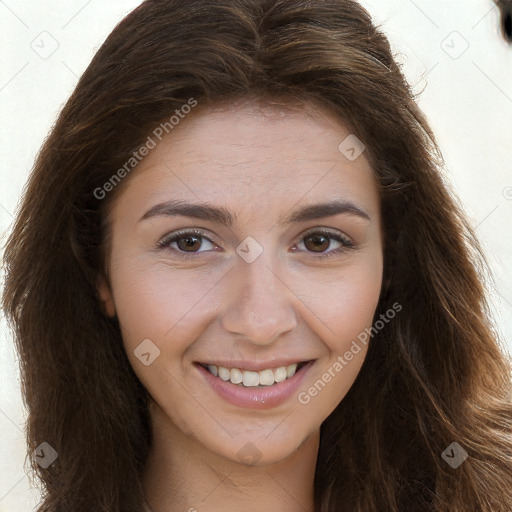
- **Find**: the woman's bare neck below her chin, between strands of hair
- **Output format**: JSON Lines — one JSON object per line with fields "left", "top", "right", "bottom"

{"left": 143, "top": 409, "right": 320, "bottom": 512}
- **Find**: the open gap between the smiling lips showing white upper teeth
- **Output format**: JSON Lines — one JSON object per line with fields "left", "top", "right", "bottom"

{"left": 196, "top": 360, "right": 313, "bottom": 388}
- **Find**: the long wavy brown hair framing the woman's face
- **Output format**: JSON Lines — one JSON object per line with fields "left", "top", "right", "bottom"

{"left": 3, "top": 0, "right": 512, "bottom": 512}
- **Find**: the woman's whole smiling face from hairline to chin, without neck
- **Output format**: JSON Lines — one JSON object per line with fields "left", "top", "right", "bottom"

{"left": 100, "top": 98, "right": 383, "bottom": 464}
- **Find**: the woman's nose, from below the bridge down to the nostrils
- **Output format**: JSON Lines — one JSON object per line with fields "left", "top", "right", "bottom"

{"left": 222, "top": 251, "right": 298, "bottom": 345}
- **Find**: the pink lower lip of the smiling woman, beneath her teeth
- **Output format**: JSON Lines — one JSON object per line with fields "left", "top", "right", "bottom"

{"left": 195, "top": 361, "right": 314, "bottom": 409}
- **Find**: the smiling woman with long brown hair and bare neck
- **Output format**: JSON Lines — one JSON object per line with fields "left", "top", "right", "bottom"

{"left": 3, "top": 0, "right": 512, "bottom": 512}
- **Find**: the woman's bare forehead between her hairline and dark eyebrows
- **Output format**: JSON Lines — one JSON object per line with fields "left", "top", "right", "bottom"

{"left": 109, "top": 102, "right": 378, "bottom": 226}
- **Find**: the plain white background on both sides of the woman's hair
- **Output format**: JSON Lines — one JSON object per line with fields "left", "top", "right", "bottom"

{"left": 0, "top": 0, "right": 512, "bottom": 512}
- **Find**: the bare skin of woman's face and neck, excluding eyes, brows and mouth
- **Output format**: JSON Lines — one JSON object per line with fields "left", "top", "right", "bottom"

{"left": 99, "top": 102, "right": 383, "bottom": 512}
